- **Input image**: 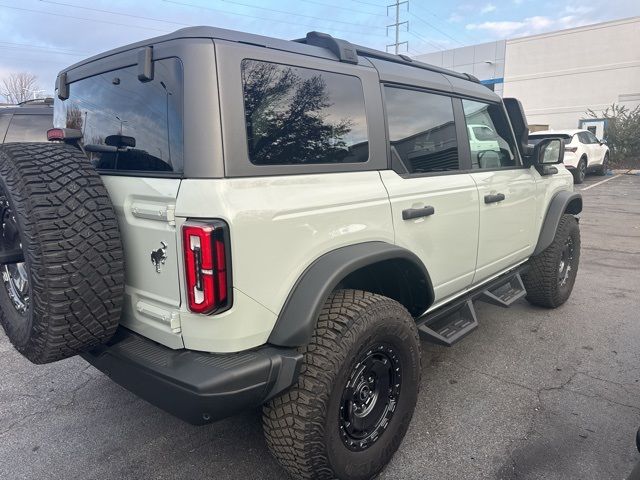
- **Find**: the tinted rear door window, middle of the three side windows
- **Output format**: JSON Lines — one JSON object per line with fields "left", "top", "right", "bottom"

{"left": 385, "top": 87, "right": 459, "bottom": 173}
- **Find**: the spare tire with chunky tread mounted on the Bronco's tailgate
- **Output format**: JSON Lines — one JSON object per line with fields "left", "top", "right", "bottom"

{"left": 0, "top": 143, "right": 124, "bottom": 363}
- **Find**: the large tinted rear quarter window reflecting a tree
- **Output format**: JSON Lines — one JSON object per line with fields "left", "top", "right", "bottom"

{"left": 242, "top": 60, "right": 369, "bottom": 165}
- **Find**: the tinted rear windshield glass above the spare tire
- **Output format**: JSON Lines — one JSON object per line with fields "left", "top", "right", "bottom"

{"left": 55, "top": 58, "right": 184, "bottom": 173}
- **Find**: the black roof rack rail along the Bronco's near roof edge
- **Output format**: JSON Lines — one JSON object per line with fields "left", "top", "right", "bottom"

{"left": 294, "top": 32, "right": 480, "bottom": 83}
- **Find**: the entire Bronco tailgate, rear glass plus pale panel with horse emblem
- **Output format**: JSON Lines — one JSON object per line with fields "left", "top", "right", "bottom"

{"left": 54, "top": 57, "right": 184, "bottom": 349}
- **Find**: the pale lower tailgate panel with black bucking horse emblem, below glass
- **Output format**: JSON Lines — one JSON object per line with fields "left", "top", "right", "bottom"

{"left": 102, "top": 175, "right": 183, "bottom": 348}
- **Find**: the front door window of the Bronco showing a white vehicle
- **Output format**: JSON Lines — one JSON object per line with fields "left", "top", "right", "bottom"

{"left": 462, "top": 100, "right": 516, "bottom": 168}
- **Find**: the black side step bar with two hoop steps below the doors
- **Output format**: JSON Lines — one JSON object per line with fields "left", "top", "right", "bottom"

{"left": 417, "top": 269, "right": 527, "bottom": 347}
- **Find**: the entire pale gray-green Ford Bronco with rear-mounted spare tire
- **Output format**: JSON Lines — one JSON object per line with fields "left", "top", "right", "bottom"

{"left": 0, "top": 27, "right": 582, "bottom": 479}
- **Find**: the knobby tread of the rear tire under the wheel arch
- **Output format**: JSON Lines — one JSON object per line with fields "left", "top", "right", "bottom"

{"left": 263, "top": 290, "right": 419, "bottom": 480}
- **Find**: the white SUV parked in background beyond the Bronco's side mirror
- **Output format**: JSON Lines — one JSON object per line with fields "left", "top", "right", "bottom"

{"left": 529, "top": 130, "right": 609, "bottom": 183}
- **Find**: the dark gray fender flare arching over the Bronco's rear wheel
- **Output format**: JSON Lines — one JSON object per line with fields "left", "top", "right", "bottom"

{"left": 268, "top": 241, "right": 434, "bottom": 347}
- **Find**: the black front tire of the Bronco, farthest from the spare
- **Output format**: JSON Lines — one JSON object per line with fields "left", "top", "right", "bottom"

{"left": 522, "top": 214, "right": 580, "bottom": 308}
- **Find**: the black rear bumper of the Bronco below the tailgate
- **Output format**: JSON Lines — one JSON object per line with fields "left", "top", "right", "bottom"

{"left": 82, "top": 327, "right": 302, "bottom": 425}
